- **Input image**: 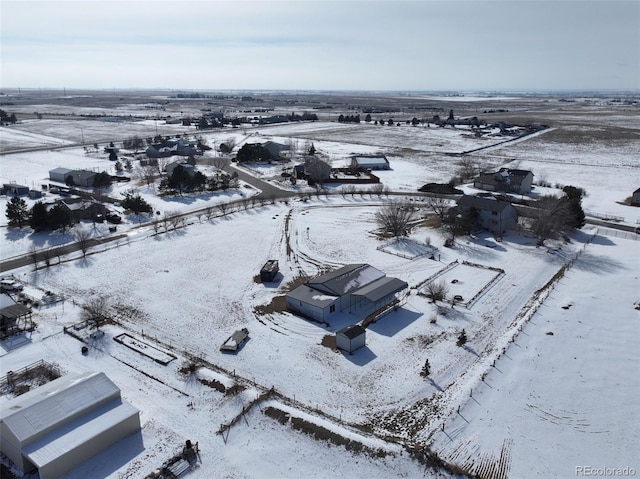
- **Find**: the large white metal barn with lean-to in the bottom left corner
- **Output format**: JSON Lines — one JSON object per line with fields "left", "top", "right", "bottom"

{"left": 0, "top": 372, "right": 140, "bottom": 479}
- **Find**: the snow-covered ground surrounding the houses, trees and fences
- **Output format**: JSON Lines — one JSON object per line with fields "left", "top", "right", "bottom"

{"left": 0, "top": 106, "right": 640, "bottom": 479}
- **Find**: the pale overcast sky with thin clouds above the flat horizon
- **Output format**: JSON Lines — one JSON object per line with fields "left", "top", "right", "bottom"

{"left": 0, "top": 0, "right": 640, "bottom": 91}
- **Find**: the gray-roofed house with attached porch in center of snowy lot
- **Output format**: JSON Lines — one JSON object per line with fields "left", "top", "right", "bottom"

{"left": 286, "top": 264, "right": 408, "bottom": 322}
